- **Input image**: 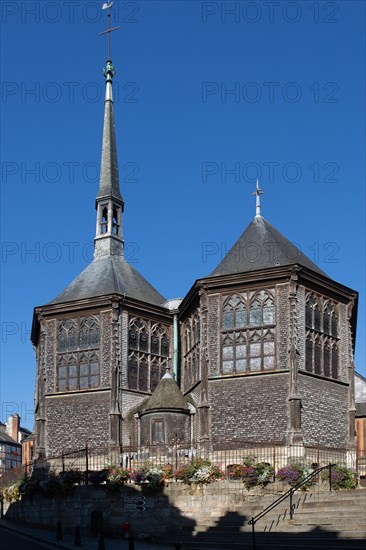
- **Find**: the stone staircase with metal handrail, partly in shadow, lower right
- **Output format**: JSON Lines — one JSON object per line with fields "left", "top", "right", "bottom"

{"left": 159, "top": 488, "right": 366, "bottom": 550}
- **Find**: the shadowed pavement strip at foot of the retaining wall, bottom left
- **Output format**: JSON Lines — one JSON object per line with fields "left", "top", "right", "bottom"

{"left": 0, "top": 519, "right": 176, "bottom": 550}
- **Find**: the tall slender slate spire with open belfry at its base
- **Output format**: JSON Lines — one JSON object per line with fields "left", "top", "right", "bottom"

{"left": 94, "top": 59, "right": 124, "bottom": 259}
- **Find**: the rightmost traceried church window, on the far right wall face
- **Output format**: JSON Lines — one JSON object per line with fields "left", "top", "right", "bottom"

{"left": 305, "top": 293, "right": 339, "bottom": 379}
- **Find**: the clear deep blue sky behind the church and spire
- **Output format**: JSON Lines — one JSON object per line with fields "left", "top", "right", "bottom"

{"left": 1, "top": 0, "right": 365, "bottom": 428}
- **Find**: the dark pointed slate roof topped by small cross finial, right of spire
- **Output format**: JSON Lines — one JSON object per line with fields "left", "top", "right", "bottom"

{"left": 209, "top": 216, "right": 328, "bottom": 277}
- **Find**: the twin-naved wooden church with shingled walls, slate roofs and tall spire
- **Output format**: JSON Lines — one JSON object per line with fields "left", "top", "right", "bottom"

{"left": 32, "top": 55, "right": 357, "bottom": 457}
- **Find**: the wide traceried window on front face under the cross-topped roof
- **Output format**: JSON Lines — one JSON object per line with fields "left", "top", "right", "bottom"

{"left": 221, "top": 289, "right": 276, "bottom": 374}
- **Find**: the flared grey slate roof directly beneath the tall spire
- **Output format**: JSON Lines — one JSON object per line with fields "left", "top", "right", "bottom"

{"left": 50, "top": 256, "right": 166, "bottom": 305}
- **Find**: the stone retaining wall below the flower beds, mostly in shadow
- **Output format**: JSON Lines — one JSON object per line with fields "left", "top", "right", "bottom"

{"left": 5, "top": 481, "right": 288, "bottom": 538}
